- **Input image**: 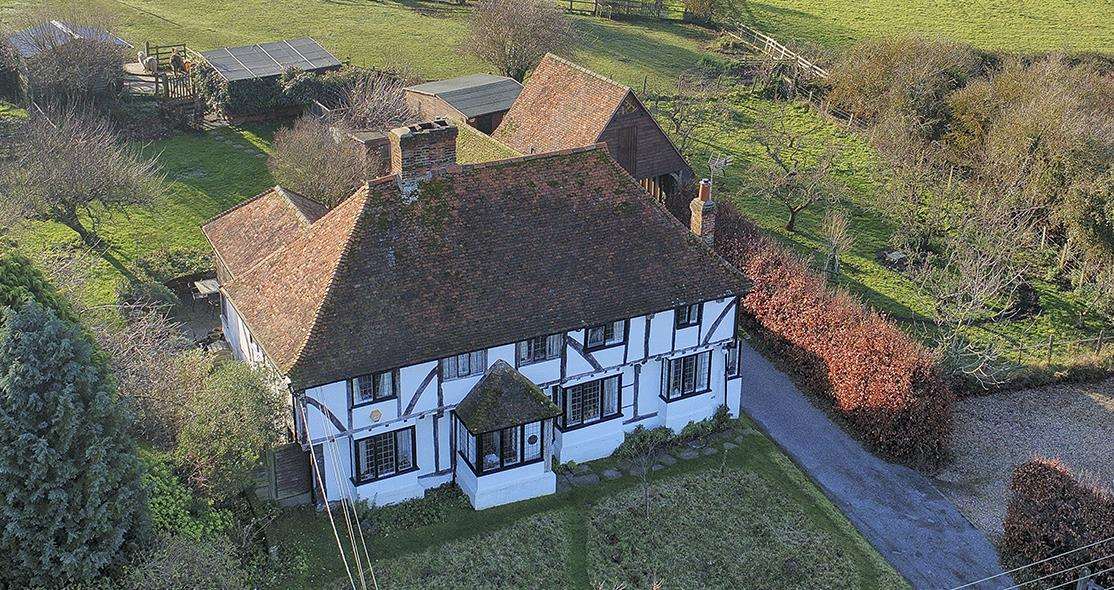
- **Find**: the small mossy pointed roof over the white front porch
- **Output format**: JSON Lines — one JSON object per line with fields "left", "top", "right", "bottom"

{"left": 456, "top": 361, "right": 560, "bottom": 434}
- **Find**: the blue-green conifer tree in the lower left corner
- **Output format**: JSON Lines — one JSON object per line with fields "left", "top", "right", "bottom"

{"left": 0, "top": 302, "right": 146, "bottom": 588}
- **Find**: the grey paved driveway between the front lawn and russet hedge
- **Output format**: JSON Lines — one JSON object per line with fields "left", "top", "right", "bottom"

{"left": 743, "top": 347, "right": 1013, "bottom": 590}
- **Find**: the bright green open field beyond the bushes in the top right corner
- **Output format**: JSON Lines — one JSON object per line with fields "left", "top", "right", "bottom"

{"left": 743, "top": 0, "right": 1114, "bottom": 52}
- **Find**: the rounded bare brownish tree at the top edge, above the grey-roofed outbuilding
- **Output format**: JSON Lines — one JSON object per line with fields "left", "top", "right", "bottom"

{"left": 461, "top": 0, "right": 574, "bottom": 81}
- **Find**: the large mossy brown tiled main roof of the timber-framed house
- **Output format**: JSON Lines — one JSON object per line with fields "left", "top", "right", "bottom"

{"left": 206, "top": 146, "right": 744, "bottom": 387}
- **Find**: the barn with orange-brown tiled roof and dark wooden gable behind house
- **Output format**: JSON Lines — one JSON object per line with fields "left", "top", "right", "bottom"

{"left": 494, "top": 53, "right": 693, "bottom": 197}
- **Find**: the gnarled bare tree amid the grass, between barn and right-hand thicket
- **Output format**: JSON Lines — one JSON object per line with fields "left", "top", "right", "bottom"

{"left": 754, "top": 111, "right": 844, "bottom": 232}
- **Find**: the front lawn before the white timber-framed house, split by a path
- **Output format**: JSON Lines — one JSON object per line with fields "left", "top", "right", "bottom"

{"left": 265, "top": 416, "right": 907, "bottom": 590}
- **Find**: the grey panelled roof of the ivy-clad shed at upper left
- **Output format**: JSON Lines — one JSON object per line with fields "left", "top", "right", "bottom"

{"left": 202, "top": 37, "right": 341, "bottom": 82}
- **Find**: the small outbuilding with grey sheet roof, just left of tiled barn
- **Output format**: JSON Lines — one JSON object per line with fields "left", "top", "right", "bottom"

{"left": 405, "top": 73, "right": 522, "bottom": 135}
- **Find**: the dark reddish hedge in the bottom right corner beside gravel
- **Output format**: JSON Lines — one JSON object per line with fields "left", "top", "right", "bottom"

{"left": 1003, "top": 456, "right": 1114, "bottom": 588}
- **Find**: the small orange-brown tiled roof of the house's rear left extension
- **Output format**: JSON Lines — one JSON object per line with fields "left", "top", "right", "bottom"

{"left": 202, "top": 186, "right": 328, "bottom": 276}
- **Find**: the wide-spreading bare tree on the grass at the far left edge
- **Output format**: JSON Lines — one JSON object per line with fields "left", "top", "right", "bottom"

{"left": 0, "top": 110, "right": 164, "bottom": 246}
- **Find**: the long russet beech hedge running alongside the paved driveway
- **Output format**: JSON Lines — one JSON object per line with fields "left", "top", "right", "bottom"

{"left": 715, "top": 206, "right": 955, "bottom": 466}
